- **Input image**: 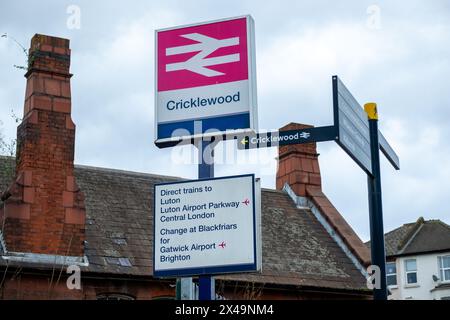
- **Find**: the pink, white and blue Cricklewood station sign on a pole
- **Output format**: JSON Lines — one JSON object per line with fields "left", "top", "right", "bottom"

{"left": 155, "top": 16, "right": 257, "bottom": 144}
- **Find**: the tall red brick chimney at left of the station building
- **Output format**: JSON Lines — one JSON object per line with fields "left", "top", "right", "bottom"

{"left": 0, "top": 34, "right": 86, "bottom": 257}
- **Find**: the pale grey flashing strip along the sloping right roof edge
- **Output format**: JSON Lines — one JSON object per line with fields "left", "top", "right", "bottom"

{"left": 283, "top": 183, "right": 368, "bottom": 279}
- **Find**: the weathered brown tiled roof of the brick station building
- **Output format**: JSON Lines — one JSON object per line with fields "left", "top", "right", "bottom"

{"left": 0, "top": 157, "right": 365, "bottom": 290}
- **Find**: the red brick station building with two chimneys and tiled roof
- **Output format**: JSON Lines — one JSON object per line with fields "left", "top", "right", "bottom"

{"left": 0, "top": 35, "right": 371, "bottom": 299}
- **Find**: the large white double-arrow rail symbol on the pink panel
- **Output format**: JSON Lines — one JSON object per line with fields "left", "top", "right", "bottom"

{"left": 166, "top": 33, "right": 240, "bottom": 77}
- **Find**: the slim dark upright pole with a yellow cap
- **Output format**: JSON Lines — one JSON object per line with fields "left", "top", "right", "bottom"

{"left": 364, "top": 103, "right": 387, "bottom": 300}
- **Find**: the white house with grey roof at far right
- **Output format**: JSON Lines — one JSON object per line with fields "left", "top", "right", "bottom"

{"left": 370, "top": 218, "right": 450, "bottom": 300}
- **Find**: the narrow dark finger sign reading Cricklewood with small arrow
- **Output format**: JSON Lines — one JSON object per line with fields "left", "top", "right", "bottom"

{"left": 237, "top": 126, "right": 336, "bottom": 149}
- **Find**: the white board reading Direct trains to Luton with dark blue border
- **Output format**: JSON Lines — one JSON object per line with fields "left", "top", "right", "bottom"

{"left": 153, "top": 174, "right": 261, "bottom": 277}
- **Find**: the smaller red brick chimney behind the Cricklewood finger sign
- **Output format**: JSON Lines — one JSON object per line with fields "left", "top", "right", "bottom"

{"left": 276, "top": 123, "right": 321, "bottom": 197}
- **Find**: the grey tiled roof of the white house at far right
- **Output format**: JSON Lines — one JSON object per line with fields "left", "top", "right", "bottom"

{"left": 367, "top": 217, "right": 450, "bottom": 257}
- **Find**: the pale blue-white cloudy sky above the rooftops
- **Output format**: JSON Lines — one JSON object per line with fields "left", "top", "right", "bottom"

{"left": 0, "top": 0, "right": 450, "bottom": 240}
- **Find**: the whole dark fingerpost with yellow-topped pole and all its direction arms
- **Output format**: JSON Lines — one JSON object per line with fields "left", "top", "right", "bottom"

{"left": 237, "top": 76, "right": 400, "bottom": 300}
